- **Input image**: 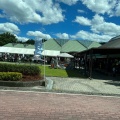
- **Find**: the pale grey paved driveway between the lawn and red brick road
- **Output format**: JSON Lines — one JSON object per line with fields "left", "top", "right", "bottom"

{"left": 51, "top": 77, "right": 120, "bottom": 96}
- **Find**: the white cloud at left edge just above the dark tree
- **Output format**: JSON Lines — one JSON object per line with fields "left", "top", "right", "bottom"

{"left": 0, "top": 23, "right": 20, "bottom": 34}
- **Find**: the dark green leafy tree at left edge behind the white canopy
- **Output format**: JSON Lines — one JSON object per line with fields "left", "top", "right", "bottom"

{"left": 0, "top": 32, "right": 17, "bottom": 46}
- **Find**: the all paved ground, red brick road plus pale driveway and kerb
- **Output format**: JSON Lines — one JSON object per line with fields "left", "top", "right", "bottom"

{"left": 0, "top": 74, "right": 120, "bottom": 120}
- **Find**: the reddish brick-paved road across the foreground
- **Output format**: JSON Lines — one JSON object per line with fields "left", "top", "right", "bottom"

{"left": 0, "top": 91, "right": 120, "bottom": 120}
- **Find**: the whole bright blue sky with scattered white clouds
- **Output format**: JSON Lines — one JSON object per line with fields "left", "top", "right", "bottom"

{"left": 0, "top": 0, "right": 120, "bottom": 42}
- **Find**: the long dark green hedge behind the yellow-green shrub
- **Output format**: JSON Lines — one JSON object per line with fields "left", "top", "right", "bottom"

{"left": 0, "top": 63, "right": 41, "bottom": 75}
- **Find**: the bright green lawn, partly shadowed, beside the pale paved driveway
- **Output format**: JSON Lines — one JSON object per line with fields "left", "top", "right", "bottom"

{"left": 39, "top": 65, "right": 83, "bottom": 77}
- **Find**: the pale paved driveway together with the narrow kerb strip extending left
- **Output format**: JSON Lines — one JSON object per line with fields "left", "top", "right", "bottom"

{"left": 0, "top": 77, "right": 120, "bottom": 97}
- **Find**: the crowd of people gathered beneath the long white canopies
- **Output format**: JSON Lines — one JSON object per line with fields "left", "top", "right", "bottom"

{"left": 0, "top": 53, "right": 71, "bottom": 69}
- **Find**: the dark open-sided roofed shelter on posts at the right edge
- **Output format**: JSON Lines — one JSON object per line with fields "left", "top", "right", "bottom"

{"left": 75, "top": 38, "right": 120, "bottom": 78}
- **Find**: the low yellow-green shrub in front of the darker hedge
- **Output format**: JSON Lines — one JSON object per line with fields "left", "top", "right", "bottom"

{"left": 0, "top": 72, "right": 22, "bottom": 81}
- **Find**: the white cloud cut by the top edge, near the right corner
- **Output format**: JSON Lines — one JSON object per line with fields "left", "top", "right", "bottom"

{"left": 81, "top": 0, "right": 117, "bottom": 15}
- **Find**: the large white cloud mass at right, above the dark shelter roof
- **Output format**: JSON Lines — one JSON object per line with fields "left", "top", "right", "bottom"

{"left": 70, "top": 14, "right": 120, "bottom": 42}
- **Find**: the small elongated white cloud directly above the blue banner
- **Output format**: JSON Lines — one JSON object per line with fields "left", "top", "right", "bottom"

{"left": 27, "top": 31, "right": 51, "bottom": 39}
